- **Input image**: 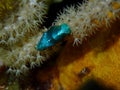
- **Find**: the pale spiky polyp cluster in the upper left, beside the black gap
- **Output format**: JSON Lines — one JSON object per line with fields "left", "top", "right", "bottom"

{"left": 0, "top": 0, "right": 46, "bottom": 46}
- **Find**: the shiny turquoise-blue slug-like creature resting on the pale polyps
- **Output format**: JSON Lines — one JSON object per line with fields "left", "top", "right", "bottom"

{"left": 36, "top": 23, "right": 71, "bottom": 50}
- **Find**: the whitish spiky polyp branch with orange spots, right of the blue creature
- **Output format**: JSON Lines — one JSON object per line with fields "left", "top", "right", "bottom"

{"left": 53, "top": 0, "right": 120, "bottom": 45}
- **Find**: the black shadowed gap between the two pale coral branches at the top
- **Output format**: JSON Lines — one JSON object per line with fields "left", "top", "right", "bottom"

{"left": 43, "top": 0, "right": 83, "bottom": 27}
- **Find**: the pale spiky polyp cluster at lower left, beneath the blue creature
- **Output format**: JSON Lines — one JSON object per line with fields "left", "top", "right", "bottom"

{"left": 5, "top": 32, "right": 57, "bottom": 76}
